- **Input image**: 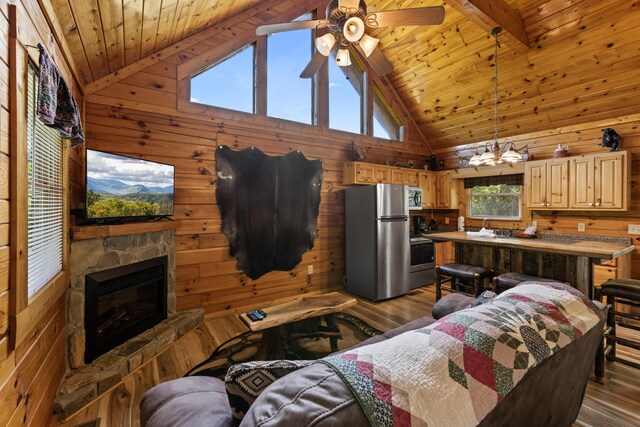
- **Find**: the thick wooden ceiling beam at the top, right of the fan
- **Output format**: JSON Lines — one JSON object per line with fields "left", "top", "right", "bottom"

{"left": 445, "top": 0, "right": 529, "bottom": 53}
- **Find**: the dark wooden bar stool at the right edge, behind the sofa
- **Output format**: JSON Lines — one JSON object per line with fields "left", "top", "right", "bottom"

{"left": 595, "top": 279, "right": 640, "bottom": 377}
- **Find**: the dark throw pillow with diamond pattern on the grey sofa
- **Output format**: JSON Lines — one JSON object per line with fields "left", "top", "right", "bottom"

{"left": 224, "top": 360, "right": 315, "bottom": 421}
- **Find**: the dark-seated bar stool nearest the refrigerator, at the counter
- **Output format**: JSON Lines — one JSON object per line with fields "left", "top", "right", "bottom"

{"left": 436, "top": 263, "right": 495, "bottom": 301}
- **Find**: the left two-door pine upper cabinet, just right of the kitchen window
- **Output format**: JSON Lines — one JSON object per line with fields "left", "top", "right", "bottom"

{"left": 524, "top": 159, "right": 569, "bottom": 209}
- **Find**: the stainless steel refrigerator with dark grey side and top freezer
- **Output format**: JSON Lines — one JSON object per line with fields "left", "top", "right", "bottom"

{"left": 345, "top": 184, "right": 411, "bottom": 301}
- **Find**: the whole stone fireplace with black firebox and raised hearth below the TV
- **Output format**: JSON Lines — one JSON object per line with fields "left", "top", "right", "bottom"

{"left": 54, "top": 229, "right": 204, "bottom": 419}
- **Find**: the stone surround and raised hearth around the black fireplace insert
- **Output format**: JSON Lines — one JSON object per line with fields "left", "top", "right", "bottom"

{"left": 54, "top": 230, "right": 204, "bottom": 419}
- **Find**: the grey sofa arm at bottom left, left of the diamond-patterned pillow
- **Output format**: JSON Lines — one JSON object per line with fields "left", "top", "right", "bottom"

{"left": 140, "top": 377, "right": 238, "bottom": 427}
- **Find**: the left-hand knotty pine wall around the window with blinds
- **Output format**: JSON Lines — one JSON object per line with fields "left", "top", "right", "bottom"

{"left": 0, "top": 0, "right": 82, "bottom": 426}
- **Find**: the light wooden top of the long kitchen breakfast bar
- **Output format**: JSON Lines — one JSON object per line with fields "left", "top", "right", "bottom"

{"left": 429, "top": 231, "right": 635, "bottom": 259}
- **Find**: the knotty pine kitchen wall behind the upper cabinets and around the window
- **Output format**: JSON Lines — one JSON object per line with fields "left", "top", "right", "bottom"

{"left": 434, "top": 114, "right": 640, "bottom": 279}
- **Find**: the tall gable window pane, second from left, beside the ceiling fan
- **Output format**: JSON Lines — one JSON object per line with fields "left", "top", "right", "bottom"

{"left": 267, "top": 14, "right": 313, "bottom": 124}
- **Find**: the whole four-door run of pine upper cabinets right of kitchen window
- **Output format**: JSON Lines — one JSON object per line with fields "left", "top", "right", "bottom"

{"left": 524, "top": 152, "right": 629, "bottom": 210}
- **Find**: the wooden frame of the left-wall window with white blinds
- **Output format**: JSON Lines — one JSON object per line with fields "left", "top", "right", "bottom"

{"left": 9, "top": 40, "right": 69, "bottom": 349}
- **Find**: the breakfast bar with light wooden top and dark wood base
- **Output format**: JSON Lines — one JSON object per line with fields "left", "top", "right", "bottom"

{"left": 429, "top": 231, "right": 635, "bottom": 297}
